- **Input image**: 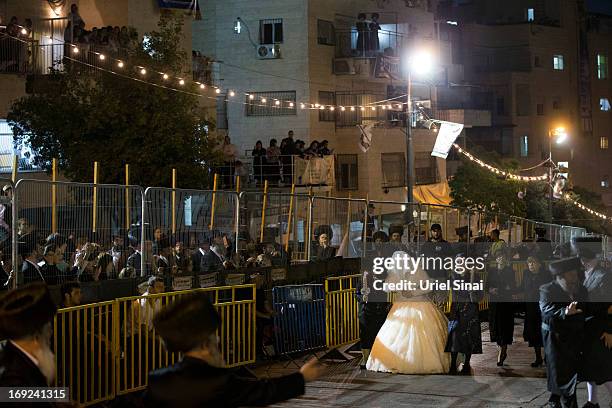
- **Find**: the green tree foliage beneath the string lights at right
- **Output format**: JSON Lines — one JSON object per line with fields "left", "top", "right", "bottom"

{"left": 449, "top": 148, "right": 526, "bottom": 221}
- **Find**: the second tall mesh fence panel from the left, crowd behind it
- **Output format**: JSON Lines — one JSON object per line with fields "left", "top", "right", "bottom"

{"left": 142, "top": 187, "right": 239, "bottom": 276}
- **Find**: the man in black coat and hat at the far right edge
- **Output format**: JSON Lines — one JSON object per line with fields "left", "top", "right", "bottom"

{"left": 572, "top": 237, "right": 612, "bottom": 408}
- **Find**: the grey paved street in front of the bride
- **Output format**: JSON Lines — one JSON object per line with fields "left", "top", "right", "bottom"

{"left": 258, "top": 319, "right": 610, "bottom": 408}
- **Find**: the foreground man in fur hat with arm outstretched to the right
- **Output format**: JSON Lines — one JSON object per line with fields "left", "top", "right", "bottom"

{"left": 144, "top": 293, "right": 320, "bottom": 408}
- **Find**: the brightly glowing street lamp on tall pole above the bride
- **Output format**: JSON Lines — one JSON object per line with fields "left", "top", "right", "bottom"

{"left": 402, "top": 49, "right": 434, "bottom": 203}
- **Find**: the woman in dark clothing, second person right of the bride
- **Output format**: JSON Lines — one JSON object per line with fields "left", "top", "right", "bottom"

{"left": 487, "top": 253, "right": 516, "bottom": 366}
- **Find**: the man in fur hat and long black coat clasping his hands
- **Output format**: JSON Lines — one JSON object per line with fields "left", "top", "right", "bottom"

{"left": 540, "top": 258, "right": 588, "bottom": 408}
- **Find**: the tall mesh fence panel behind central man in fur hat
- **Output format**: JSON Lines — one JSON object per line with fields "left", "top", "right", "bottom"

{"left": 310, "top": 197, "right": 373, "bottom": 260}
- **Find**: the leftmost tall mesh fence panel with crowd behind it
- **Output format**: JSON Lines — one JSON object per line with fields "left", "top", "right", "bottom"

{"left": 15, "top": 179, "right": 142, "bottom": 285}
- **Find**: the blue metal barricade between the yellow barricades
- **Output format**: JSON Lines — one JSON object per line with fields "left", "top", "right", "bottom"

{"left": 272, "top": 284, "right": 325, "bottom": 355}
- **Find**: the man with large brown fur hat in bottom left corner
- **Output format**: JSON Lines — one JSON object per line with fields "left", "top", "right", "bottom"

{"left": 0, "top": 283, "right": 56, "bottom": 406}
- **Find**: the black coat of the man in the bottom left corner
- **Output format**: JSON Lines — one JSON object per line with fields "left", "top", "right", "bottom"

{"left": 0, "top": 340, "right": 53, "bottom": 407}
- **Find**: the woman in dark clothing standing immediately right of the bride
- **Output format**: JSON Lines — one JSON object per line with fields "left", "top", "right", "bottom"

{"left": 444, "top": 254, "right": 483, "bottom": 374}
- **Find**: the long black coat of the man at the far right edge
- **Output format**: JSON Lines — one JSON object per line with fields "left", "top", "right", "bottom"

{"left": 580, "top": 265, "right": 612, "bottom": 384}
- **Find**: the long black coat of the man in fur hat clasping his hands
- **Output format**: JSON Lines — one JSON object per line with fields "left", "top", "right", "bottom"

{"left": 540, "top": 281, "right": 588, "bottom": 396}
